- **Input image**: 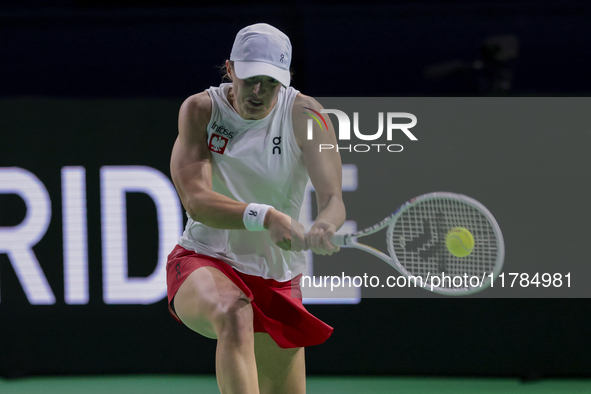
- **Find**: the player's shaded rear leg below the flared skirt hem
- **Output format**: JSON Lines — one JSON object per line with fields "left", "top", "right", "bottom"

{"left": 254, "top": 332, "right": 306, "bottom": 394}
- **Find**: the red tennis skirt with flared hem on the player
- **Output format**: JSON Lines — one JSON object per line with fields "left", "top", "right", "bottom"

{"left": 166, "top": 245, "right": 333, "bottom": 349}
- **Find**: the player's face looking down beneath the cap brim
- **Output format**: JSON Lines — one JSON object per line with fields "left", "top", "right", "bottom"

{"left": 231, "top": 62, "right": 281, "bottom": 119}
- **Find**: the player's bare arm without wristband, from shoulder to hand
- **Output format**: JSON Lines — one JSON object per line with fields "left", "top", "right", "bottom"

{"left": 292, "top": 94, "right": 346, "bottom": 254}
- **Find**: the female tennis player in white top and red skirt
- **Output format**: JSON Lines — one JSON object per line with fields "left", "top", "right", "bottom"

{"left": 167, "top": 24, "right": 345, "bottom": 394}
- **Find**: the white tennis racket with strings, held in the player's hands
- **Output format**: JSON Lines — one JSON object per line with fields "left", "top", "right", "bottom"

{"left": 331, "top": 192, "right": 505, "bottom": 295}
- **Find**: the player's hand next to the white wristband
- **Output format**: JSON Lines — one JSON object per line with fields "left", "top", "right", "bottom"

{"left": 264, "top": 209, "right": 308, "bottom": 252}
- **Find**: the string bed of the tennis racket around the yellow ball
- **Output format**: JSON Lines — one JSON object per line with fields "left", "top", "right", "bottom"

{"left": 388, "top": 198, "right": 498, "bottom": 287}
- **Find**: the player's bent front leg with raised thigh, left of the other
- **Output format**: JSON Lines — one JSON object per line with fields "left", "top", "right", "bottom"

{"left": 174, "top": 267, "right": 258, "bottom": 394}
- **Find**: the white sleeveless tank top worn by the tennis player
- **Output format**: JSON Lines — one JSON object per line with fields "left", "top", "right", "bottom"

{"left": 179, "top": 83, "right": 308, "bottom": 282}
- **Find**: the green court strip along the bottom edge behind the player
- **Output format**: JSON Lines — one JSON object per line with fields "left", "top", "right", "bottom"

{"left": 0, "top": 375, "right": 591, "bottom": 394}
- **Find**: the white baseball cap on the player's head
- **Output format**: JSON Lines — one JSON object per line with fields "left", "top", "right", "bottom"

{"left": 230, "top": 23, "right": 291, "bottom": 86}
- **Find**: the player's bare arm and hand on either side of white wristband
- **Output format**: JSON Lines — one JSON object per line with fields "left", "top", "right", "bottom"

{"left": 170, "top": 92, "right": 305, "bottom": 250}
